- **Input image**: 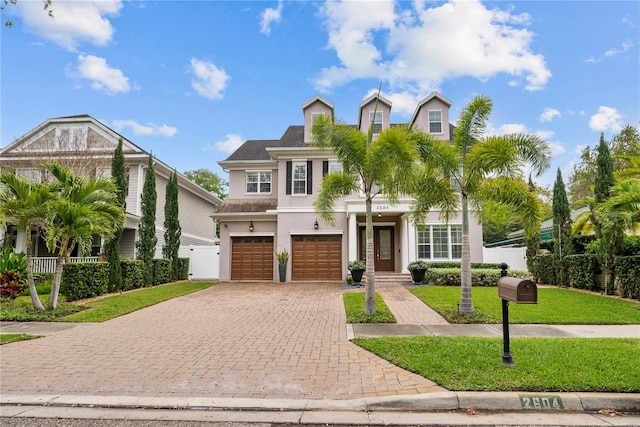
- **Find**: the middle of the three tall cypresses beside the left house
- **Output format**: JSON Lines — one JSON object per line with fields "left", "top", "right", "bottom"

{"left": 136, "top": 154, "right": 158, "bottom": 286}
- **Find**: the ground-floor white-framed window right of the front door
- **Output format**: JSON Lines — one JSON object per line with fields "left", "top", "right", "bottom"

{"left": 417, "top": 225, "right": 462, "bottom": 260}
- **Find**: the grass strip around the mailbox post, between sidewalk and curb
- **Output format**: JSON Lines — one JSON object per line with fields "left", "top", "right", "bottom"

{"left": 353, "top": 337, "right": 640, "bottom": 393}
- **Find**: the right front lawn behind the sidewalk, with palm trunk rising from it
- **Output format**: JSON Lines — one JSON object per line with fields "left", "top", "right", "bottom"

{"left": 409, "top": 286, "right": 640, "bottom": 325}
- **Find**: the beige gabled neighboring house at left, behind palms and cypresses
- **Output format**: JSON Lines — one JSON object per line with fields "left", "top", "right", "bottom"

{"left": 0, "top": 115, "right": 222, "bottom": 258}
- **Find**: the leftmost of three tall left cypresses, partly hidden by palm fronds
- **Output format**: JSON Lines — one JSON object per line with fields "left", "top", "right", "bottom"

{"left": 104, "top": 139, "right": 127, "bottom": 292}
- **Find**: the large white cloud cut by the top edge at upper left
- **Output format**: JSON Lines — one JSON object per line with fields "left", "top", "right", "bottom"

{"left": 16, "top": 0, "right": 122, "bottom": 51}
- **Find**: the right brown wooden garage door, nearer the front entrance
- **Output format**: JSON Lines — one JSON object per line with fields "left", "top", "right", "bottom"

{"left": 291, "top": 235, "right": 342, "bottom": 280}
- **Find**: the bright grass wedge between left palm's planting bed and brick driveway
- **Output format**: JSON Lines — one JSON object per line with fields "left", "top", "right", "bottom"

{"left": 55, "top": 281, "right": 215, "bottom": 322}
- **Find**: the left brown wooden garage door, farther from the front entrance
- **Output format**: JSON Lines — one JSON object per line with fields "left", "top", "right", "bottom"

{"left": 231, "top": 236, "right": 275, "bottom": 280}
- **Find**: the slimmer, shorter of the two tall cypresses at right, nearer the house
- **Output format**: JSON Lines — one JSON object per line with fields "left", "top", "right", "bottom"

{"left": 553, "top": 168, "right": 571, "bottom": 287}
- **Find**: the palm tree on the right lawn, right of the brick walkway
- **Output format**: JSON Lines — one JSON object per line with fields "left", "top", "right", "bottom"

{"left": 412, "top": 95, "right": 550, "bottom": 314}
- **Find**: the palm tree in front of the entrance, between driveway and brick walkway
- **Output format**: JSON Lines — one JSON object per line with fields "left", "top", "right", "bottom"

{"left": 312, "top": 110, "right": 438, "bottom": 314}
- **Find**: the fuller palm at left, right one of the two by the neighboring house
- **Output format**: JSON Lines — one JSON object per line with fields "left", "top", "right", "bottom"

{"left": 45, "top": 162, "right": 125, "bottom": 309}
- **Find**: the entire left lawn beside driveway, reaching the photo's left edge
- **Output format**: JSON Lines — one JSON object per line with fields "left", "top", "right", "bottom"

{"left": 0, "top": 281, "right": 215, "bottom": 322}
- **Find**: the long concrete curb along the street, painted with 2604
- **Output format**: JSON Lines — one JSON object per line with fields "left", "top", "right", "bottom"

{"left": 0, "top": 392, "right": 640, "bottom": 413}
